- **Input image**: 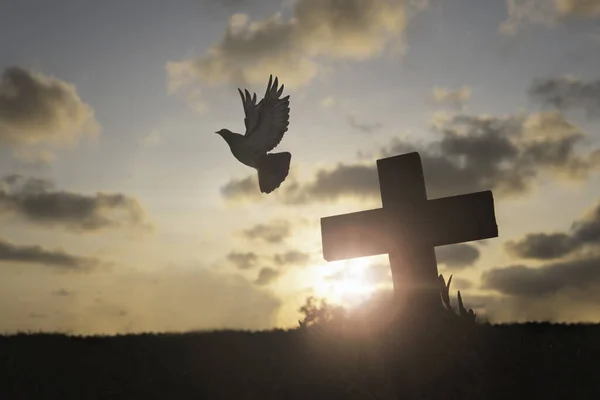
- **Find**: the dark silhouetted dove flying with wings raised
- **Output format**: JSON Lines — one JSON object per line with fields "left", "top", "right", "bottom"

{"left": 216, "top": 75, "right": 292, "bottom": 193}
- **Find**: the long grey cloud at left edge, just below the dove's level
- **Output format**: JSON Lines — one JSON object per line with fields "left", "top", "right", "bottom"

{"left": 0, "top": 175, "right": 150, "bottom": 232}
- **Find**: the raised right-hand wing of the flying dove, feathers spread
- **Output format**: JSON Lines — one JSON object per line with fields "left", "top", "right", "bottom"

{"left": 246, "top": 75, "right": 290, "bottom": 153}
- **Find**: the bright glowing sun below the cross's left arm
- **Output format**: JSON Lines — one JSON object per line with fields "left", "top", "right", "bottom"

{"left": 314, "top": 257, "right": 373, "bottom": 306}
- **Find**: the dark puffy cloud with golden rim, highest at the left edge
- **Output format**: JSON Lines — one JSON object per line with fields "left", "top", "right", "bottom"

{"left": 0, "top": 67, "right": 100, "bottom": 145}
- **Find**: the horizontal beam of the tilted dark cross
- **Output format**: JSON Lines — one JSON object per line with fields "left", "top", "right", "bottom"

{"left": 321, "top": 190, "right": 498, "bottom": 261}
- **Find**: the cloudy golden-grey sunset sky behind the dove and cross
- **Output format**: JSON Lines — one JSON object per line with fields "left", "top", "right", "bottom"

{"left": 0, "top": 0, "right": 600, "bottom": 334}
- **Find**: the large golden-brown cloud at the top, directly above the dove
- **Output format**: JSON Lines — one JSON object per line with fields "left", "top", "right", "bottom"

{"left": 167, "top": 0, "right": 418, "bottom": 92}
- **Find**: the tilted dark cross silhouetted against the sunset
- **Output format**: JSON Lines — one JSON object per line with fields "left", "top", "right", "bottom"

{"left": 321, "top": 152, "right": 498, "bottom": 314}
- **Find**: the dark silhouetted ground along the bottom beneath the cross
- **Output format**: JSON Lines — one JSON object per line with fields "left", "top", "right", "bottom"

{"left": 0, "top": 323, "right": 600, "bottom": 400}
